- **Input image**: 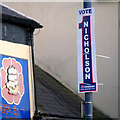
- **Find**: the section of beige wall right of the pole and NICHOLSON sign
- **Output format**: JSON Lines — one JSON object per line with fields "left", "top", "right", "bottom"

{"left": 94, "top": 3, "right": 118, "bottom": 118}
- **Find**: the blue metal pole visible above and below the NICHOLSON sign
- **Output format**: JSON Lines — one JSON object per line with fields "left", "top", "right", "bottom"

{"left": 83, "top": 0, "right": 93, "bottom": 120}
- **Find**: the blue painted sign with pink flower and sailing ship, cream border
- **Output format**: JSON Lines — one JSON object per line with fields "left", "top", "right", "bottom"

{"left": 0, "top": 40, "right": 34, "bottom": 119}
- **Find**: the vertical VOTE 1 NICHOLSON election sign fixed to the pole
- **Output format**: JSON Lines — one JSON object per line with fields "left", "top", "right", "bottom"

{"left": 77, "top": 8, "right": 97, "bottom": 93}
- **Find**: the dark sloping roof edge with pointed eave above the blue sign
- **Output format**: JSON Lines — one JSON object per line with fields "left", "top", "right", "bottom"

{"left": 0, "top": 3, "right": 43, "bottom": 29}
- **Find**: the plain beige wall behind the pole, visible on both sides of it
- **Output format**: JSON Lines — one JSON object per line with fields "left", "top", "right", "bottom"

{"left": 5, "top": 2, "right": 118, "bottom": 118}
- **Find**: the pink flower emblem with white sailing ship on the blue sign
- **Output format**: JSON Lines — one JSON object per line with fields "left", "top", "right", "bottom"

{"left": 0, "top": 58, "right": 24, "bottom": 105}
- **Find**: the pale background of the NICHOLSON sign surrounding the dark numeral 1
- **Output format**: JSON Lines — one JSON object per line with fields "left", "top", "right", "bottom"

{"left": 77, "top": 8, "right": 98, "bottom": 93}
